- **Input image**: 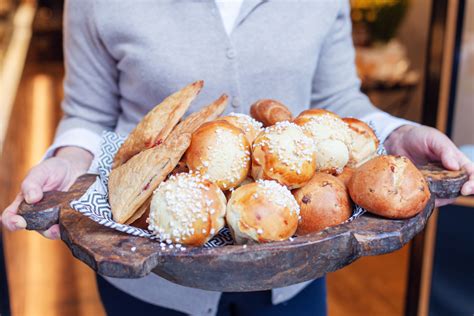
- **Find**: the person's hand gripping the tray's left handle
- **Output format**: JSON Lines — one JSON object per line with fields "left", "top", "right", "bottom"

{"left": 1, "top": 147, "right": 92, "bottom": 239}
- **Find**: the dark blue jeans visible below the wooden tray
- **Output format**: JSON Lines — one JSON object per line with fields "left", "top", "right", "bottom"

{"left": 97, "top": 276, "right": 327, "bottom": 316}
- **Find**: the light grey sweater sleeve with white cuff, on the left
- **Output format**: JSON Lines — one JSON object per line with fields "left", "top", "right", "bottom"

{"left": 53, "top": 0, "right": 120, "bottom": 150}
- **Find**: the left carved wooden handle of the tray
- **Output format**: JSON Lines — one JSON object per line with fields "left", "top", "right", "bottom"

{"left": 18, "top": 174, "right": 97, "bottom": 231}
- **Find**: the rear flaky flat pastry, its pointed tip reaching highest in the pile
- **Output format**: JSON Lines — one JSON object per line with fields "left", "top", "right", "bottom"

{"left": 112, "top": 80, "right": 204, "bottom": 168}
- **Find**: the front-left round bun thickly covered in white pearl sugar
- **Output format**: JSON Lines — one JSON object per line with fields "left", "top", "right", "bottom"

{"left": 148, "top": 173, "right": 226, "bottom": 246}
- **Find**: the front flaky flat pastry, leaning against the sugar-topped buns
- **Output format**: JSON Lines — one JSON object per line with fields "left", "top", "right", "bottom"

{"left": 109, "top": 95, "right": 227, "bottom": 224}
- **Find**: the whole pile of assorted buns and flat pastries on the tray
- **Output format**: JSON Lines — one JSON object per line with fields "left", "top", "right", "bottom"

{"left": 109, "top": 81, "right": 430, "bottom": 246}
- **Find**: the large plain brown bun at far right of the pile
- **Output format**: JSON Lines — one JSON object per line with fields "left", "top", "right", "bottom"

{"left": 349, "top": 156, "right": 430, "bottom": 218}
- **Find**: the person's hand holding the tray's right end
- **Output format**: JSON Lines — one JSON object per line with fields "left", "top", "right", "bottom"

{"left": 384, "top": 125, "right": 474, "bottom": 206}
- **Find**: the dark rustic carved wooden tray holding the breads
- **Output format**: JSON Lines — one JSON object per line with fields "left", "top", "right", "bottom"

{"left": 19, "top": 165, "right": 468, "bottom": 292}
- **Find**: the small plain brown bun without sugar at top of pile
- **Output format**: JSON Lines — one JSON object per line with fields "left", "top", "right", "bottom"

{"left": 250, "top": 99, "right": 293, "bottom": 126}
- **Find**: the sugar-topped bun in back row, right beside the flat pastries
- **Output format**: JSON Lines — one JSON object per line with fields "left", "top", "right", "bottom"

{"left": 185, "top": 120, "right": 250, "bottom": 190}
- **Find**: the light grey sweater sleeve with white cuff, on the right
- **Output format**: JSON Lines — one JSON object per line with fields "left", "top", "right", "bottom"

{"left": 311, "top": 0, "right": 414, "bottom": 142}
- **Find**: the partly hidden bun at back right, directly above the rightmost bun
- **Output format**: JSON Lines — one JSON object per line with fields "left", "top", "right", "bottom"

{"left": 343, "top": 117, "right": 379, "bottom": 168}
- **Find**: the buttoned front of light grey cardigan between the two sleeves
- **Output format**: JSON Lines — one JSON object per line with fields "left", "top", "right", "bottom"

{"left": 91, "top": 0, "right": 340, "bottom": 134}
